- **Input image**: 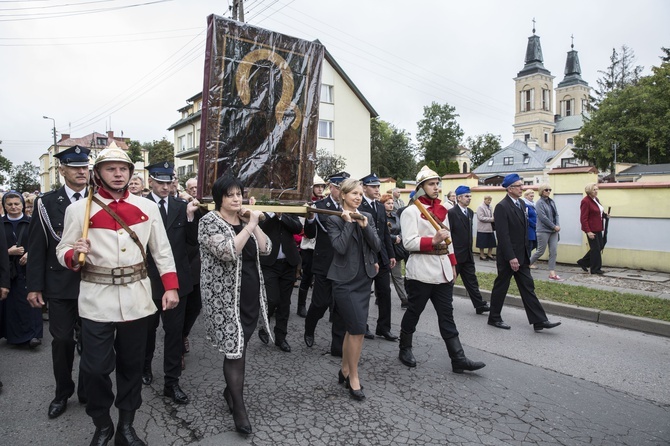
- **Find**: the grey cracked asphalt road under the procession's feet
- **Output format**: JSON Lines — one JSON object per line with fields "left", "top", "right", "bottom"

{"left": 0, "top": 286, "right": 670, "bottom": 446}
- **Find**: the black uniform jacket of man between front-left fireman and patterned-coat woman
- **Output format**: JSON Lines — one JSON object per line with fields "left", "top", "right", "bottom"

{"left": 147, "top": 194, "right": 198, "bottom": 300}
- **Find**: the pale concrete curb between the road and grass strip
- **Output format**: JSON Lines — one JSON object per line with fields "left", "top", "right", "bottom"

{"left": 454, "top": 285, "right": 670, "bottom": 338}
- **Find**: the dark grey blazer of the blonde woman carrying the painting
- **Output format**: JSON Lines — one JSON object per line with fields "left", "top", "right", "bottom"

{"left": 326, "top": 213, "right": 380, "bottom": 282}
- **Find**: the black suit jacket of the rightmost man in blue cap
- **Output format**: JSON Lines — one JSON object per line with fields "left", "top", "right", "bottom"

{"left": 493, "top": 195, "right": 530, "bottom": 266}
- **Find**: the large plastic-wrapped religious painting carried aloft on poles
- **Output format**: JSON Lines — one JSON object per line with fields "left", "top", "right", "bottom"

{"left": 198, "top": 15, "right": 324, "bottom": 201}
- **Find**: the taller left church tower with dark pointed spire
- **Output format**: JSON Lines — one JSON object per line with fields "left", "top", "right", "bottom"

{"left": 514, "top": 24, "right": 555, "bottom": 150}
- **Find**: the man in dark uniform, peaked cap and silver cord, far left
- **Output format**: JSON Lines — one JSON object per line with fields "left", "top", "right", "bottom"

{"left": 27, "top": 146, "right": 90, "bottom": 418}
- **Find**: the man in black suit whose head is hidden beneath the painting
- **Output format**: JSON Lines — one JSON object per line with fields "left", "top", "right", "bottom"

{"left": 258, "top": 212, "right": 302, "bottom": 352}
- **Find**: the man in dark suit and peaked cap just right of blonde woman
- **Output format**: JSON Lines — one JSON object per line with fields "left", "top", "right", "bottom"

{"left": 359, "top": 173, "right": 398, "bottom": 341}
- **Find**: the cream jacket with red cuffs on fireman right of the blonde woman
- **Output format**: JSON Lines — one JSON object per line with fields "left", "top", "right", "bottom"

{"left": 400, "top": 205, "right": 456, "bottom": 284}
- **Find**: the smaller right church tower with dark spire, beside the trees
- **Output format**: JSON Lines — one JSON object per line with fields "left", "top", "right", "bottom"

{"left": 555, "top": 38, "right": 591, "bottom": 149}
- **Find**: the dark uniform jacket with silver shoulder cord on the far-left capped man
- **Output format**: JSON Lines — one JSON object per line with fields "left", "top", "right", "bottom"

{"left": 26, "top": 186, "right": 80, "bottom": 299}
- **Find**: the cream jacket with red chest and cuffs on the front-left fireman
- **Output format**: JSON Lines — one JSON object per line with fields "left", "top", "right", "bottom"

{"left": 56, "top": 189, "right": 179, "bottom": 322}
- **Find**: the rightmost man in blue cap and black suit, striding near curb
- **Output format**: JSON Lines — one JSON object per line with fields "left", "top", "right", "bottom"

{"left": 488, "top": 173, "right": 561, "bottom": 331}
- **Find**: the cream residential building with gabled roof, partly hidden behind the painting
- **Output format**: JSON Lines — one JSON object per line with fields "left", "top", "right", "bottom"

{"left": 168, "top": 51, "right": 378, "bottom": 188}
